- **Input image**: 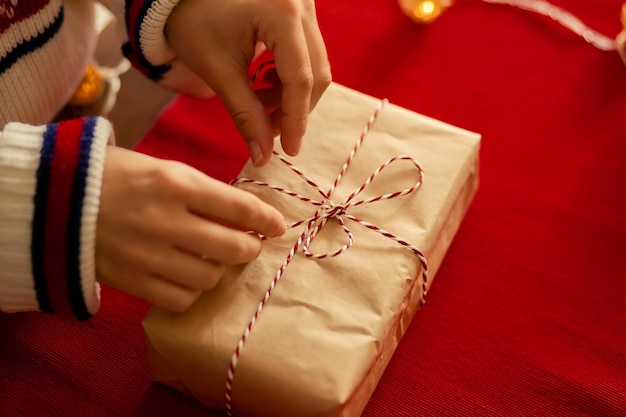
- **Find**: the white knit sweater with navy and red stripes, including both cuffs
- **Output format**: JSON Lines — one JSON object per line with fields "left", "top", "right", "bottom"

{"left": 0, "top": 0, "right": 183, "bottom": 320}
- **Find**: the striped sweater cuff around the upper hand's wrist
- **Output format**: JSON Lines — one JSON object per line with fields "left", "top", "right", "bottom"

{"left": 122, "top": 0, "right": 180, "bottom": 81}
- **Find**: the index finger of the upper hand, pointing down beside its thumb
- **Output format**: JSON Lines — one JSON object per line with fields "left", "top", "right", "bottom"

{"left": 270, "top": 16, "right": 313, "bottom": 155}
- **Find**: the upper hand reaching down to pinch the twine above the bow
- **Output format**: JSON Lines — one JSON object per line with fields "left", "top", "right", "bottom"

{"left": 165, "top": 0, "right": 331, "bottom": 166}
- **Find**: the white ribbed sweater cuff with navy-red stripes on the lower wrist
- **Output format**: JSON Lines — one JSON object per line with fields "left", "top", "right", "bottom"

{"left": 0, "top": 117, "right": 112, "bottom": 320}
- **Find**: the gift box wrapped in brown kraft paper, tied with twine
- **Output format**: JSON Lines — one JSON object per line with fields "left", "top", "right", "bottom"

{"left": 143, "top": 84, "right": 480, "bottom": 417}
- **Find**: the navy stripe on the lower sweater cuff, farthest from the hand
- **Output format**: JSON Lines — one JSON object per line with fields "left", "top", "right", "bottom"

{"left": 31, "top": 124, "right": 58, "bottom": 313}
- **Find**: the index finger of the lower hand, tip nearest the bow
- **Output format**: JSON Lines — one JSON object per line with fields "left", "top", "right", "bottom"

{"left": 187, "top": 173, "right": 286, "bottom": 236}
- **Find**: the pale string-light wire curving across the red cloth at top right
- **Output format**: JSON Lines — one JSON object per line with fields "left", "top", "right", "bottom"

{"left": 483, "top": 0, "right": 626, "bottom": 50}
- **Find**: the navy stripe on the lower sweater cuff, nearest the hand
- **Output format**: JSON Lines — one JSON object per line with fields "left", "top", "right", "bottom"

{"left": 66, "top": 117, "right": 97, "bottom": 320}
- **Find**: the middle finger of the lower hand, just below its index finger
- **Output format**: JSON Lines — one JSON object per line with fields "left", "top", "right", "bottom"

{"left": 177, "top": 215, "right": 261, "bottom": 264}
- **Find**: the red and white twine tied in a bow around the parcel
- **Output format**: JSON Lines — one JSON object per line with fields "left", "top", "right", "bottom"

{"left": 225, "top": 100, "right": 428, "bottom": 416}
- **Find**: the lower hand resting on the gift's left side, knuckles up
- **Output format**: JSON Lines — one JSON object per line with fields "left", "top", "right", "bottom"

{"left": 96, "top": 147, "right": 285, "bottom": 311}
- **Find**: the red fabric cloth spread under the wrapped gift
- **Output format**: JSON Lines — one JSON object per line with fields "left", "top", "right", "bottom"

{"left": 0, "top": 0, "right": 626, "bottom": 416}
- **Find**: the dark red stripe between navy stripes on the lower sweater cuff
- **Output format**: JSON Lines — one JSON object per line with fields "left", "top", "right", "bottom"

{"left": 44, "top": 119, "right": 84, "bottom": 317}
